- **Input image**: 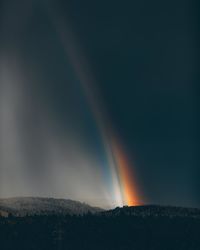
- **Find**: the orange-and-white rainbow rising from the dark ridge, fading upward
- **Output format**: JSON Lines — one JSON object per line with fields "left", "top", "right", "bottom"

{"left": 46, "top": 4, "right": 140, "bottom": 206}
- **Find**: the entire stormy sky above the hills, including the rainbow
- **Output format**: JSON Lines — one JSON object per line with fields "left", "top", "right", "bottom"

{"left": 0, "top": 0, "right": 200, "bottom": 207}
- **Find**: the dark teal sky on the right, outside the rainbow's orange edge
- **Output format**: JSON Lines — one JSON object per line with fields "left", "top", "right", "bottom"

{"left": 56, "top": 0, "right": 199, "bottom": 205}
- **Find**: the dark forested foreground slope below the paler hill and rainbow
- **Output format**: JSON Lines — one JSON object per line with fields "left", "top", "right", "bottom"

{"left": 0, "top": 206, "right": 200, "bottom": 250}
